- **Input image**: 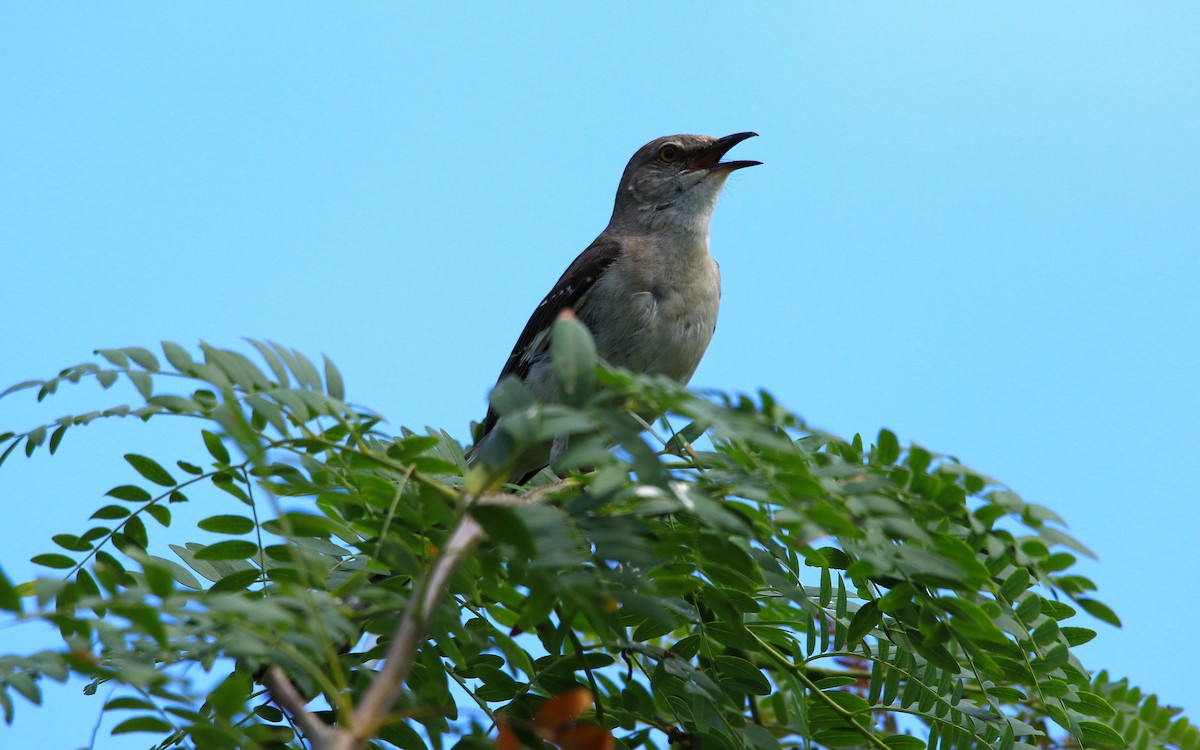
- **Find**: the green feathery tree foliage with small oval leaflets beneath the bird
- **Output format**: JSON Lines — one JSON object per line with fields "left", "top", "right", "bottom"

{"left": 0, "top": 322, "right": 1200, "bottom": 750}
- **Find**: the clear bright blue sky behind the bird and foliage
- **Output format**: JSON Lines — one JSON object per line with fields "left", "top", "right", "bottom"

{"left": 0, "top": 2, "right": 1200, "bottom": 748}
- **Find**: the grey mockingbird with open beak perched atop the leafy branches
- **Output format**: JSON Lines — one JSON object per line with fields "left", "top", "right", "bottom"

{"left": 468, "top": 133, "right": 762, "bottom": 482}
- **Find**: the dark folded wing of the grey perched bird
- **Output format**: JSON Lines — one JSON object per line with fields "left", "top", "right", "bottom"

{"left": 476, "top": 238, "right": 620, "bottom": 443}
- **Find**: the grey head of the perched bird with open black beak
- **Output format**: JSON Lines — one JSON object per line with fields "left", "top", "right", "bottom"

{"left": 612, "top": 133, "right": 762, "bottom": 234}
